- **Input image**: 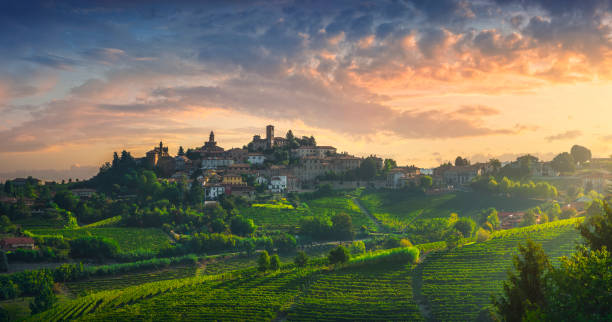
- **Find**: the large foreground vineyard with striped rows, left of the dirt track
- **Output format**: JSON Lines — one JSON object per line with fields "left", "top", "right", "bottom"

{"left": 32, "top": 248, "right": 419, "bottom": 321}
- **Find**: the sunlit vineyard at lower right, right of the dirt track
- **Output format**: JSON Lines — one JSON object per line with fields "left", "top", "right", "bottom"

{"left": 415, "top": 219, "right": 579, "bottom": 321}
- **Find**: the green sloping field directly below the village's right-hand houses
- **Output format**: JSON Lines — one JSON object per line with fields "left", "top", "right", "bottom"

{"left": 359, "top": 191, "right": 542, "bottom": 230}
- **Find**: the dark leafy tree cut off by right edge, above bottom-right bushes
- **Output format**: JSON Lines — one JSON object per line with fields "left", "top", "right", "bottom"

{"left": 579, "top": 203, "right": 612, "bottom": 251}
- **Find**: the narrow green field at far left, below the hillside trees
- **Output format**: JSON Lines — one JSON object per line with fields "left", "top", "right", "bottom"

{"left": 30, "top": 228, "right": 170, "bottom": 252}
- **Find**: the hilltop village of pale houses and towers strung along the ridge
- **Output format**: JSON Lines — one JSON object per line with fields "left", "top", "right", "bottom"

{"left": 129, "top": 125, "right": 608, "bottom": 200}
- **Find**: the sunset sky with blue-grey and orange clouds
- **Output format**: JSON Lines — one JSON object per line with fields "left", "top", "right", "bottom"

{"left": 0, "top": 0, "right": 612, "bottom": 178}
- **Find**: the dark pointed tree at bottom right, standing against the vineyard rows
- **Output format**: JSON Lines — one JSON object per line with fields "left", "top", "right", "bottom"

{"left": 493, "top": 239, "right": 551, "bottom": 321}
